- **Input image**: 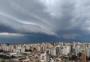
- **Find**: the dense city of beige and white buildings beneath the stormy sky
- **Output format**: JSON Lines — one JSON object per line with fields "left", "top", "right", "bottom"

{"left": 0, "top": 42, "right": 90, "bottom": 62}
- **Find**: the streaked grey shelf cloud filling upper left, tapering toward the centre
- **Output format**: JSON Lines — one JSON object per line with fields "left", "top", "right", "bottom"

{"left": 0, "top": 0, "right": 54, "bottom": 34}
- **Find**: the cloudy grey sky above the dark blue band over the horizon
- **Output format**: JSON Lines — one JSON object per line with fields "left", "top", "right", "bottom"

{"left": 0, "top": 0, "right": 90, "bottom": 40}
